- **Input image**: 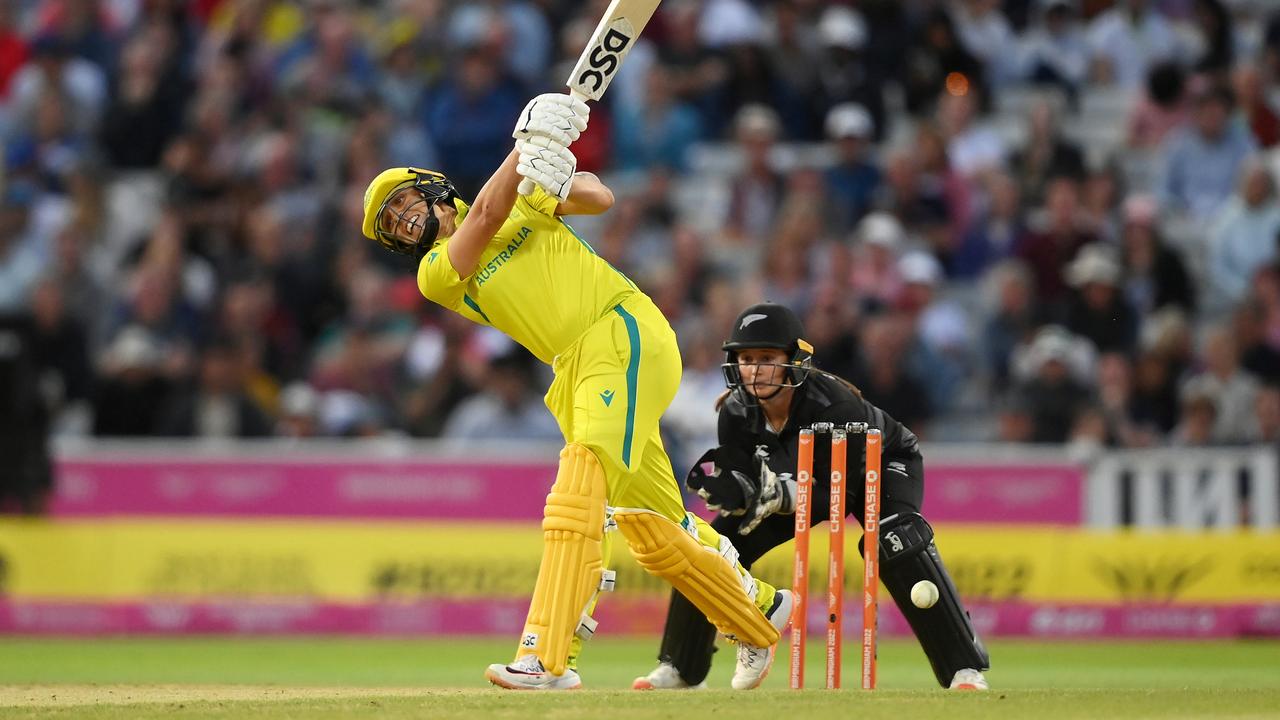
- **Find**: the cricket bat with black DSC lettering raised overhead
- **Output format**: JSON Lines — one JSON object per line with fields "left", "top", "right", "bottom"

{"left": 520, "top": 0, "right": 659, "bottom": 195}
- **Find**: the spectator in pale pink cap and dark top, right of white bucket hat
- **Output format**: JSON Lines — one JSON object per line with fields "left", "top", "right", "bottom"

{"left": 1120, "top": 195, "right": 1196, "bottom": 316}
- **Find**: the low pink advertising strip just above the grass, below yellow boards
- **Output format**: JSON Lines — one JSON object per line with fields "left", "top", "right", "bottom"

{"left": 0, "top": 597, "right": 1280, "bottom": 639}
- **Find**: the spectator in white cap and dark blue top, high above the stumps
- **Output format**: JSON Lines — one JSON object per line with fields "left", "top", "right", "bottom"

{"left": 826, "top": 102, "right": 882, "bottom": 230}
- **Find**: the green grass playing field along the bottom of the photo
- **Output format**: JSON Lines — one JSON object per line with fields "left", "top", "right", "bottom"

{"left": 0, "top": 638, "right": 1280, "bottom": 720}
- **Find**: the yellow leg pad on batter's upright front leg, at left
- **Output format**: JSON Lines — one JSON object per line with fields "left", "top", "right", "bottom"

{"left": 516, "top": 443, "right": 605, "bottom": 675}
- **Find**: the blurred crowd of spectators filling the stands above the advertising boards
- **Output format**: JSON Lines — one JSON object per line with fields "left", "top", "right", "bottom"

{"left": 0, "top": 0, "right": 1280, "bottom": 491}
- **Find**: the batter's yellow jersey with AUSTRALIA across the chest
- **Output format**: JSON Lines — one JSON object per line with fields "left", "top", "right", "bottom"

{"left": 417, "top": 187, "right": 640, "bottom": 364}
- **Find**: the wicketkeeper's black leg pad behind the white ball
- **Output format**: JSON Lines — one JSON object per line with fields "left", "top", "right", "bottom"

{"left": 875, "top": 512, "right": 991, "bottom": 688}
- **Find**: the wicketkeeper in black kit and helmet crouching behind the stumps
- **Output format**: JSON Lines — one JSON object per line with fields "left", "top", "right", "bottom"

{"left": 632, "top": 304, "right": 991, "bottom": 689}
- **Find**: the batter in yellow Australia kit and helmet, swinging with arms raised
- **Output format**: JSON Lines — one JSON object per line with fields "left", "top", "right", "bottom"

{"left": 362, "top": 94, "right": 792, "bottom": 689}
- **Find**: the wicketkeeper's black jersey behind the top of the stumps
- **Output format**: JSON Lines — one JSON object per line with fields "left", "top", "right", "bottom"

{"left": 719, "top": 370, "right": 920, "bottom": 495}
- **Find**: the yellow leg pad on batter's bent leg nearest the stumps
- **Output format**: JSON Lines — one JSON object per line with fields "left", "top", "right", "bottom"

{"left": 613, "top": 507, "right": 778, "bottom": 647}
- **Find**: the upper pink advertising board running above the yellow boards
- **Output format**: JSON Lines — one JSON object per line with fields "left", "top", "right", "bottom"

{"left": 52, "top": 452, "right": 1084, "bottom": 525}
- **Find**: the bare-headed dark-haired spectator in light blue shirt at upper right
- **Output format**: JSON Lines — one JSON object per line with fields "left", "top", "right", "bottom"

{"left": 1161, "top": 85, "right": 1257, "bottom": 223}
